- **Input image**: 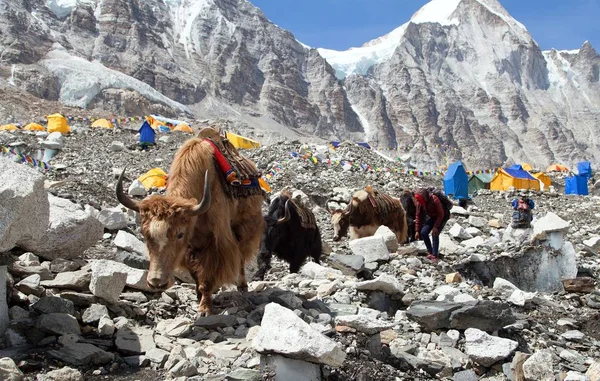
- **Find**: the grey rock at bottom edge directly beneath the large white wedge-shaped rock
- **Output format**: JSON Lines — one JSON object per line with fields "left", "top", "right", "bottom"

{"left": 260, "top": 356, "right": 321, "bottom": 381}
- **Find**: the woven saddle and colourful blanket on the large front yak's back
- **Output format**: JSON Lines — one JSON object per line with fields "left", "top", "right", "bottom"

{"left": 198, "top": 127, "right": 268, "bottom": 198}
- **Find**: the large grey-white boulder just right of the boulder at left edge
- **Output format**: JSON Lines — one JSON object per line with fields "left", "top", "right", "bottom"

{"left": 21, "top": 194, "right": 104, "bottom": 259}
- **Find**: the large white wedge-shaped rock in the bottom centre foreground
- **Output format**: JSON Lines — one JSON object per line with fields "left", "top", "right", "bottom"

{"left": 252, "top": 303, "right": 346, "bottom": 367}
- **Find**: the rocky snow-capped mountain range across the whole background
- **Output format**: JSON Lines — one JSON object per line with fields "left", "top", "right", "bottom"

{"left": 0, "top": 0, "right": 600, "bottom": 169}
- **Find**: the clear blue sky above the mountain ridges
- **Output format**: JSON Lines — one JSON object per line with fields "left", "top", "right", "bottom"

{"left": 250, "top": 0, "right": 600, "bottom": 50}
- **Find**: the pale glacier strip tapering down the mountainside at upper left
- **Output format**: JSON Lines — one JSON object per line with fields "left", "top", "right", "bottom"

{"left": 41, "top": 49, "right": 189, "bottom": 112}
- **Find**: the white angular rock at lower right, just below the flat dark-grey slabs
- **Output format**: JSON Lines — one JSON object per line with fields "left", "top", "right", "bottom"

{"left": 465, "top": 328, "right": 518, "bottom": 367}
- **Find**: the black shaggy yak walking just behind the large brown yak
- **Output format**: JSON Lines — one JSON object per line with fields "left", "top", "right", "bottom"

{"left": 252, "top": 190, "right": 322, "bottom": 280}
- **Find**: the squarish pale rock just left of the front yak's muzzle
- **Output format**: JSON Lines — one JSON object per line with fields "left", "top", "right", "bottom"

{"left": 90, "top": 260, "right": 127, "bottom": 303}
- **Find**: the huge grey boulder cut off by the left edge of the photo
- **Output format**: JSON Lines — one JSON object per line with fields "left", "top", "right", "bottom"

{"left": 0, "top": 157, "right": 50, "bottom": 252}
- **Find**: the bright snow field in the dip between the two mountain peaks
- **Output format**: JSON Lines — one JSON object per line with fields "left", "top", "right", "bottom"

{"left": 317, "top": 24, "right": 408, "bottom": 79}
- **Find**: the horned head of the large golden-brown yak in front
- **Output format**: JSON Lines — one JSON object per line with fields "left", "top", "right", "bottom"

{"left": 116, "top": 170, "right": 211, "bottom": 290}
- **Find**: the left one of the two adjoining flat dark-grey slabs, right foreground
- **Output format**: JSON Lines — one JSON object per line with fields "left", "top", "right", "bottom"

{"left": 406, "top": 301, "right": 463, "bottom": 331}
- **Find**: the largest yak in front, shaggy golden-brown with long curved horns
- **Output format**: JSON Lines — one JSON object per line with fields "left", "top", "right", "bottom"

{"left": 116, "top": 138, "right": 264, "bottom": 315}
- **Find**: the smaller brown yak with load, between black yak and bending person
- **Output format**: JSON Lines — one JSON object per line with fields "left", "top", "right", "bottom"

{"left": 329, "top": 185, "right": 408, "bottom": 243}
